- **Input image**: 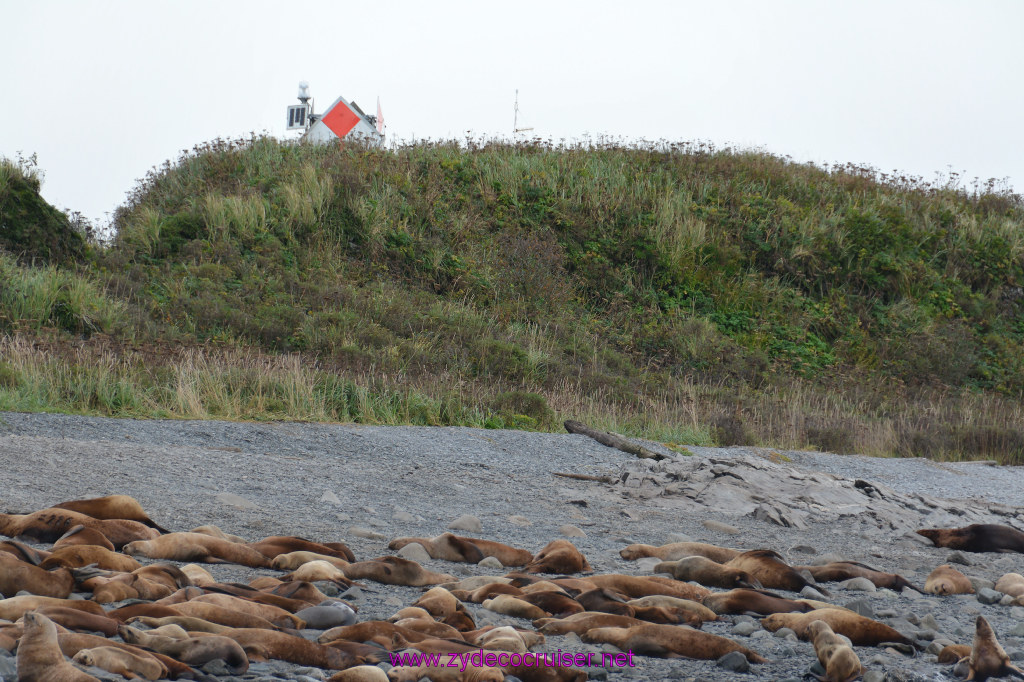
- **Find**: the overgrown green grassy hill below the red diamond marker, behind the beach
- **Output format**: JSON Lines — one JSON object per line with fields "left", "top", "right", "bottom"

{"left": 0, "top": 138, "right": 1024, "bottom": 461}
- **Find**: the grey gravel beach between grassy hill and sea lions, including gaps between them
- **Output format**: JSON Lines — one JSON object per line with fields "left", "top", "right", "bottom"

{"left": 0, "top": 413, "right": 1024, "bottom": 682}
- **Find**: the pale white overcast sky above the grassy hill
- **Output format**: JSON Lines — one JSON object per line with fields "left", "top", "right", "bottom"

{"left": 0, "top": 0, "right": 1024, "bottom": 224}
